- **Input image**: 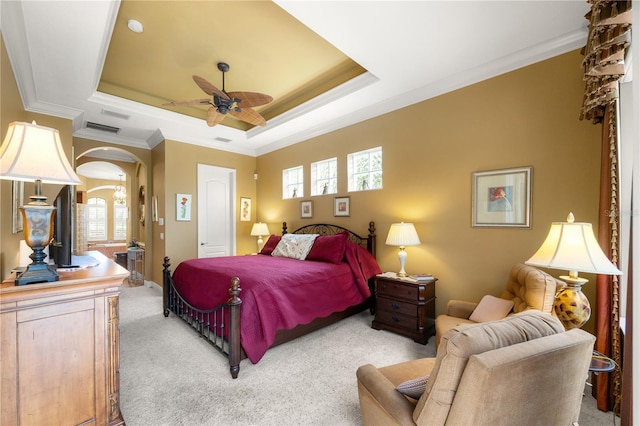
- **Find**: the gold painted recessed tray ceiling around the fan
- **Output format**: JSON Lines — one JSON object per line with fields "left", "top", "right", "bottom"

{"left": 98, "top": 0, "right": 365, "bottom": 130}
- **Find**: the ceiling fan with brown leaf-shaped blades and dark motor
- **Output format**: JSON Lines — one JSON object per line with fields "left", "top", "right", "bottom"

{"left": 163, "top": 62, "right": 273, "bottom": 127}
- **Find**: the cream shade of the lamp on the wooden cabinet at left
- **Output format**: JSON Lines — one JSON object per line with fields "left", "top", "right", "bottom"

{"left": 0, "top": 121, "right": 82, "bottom": 185}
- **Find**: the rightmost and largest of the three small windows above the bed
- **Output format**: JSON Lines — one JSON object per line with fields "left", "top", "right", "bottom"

{"left": 347, "top": 146, "right": 382, "bottom": 192}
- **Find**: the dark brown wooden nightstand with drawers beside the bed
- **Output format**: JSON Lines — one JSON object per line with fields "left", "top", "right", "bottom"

{"left": 371, "top": 272, "right": 438, "bottom": 345}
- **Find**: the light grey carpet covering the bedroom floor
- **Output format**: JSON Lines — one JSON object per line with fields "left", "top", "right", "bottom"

{"left": 120, "top": 284, "right": 613, "bottom": 426}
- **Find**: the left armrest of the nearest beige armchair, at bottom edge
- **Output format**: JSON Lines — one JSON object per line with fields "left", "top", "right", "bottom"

{"left": 356, "top": 364, "right": 415, "bottom": 426}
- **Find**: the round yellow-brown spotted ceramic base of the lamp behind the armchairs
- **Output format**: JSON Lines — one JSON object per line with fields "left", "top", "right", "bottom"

{"left": 553, "top": 276, "right": 591, "bottom": 330}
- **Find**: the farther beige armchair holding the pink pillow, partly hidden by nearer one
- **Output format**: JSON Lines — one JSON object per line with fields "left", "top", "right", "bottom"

{"left": 435, "top": 264, "right": 565, "bottom": 350}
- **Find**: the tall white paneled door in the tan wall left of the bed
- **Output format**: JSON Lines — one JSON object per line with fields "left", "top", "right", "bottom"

{"left": 198, "top": 164, "right": 236, "bottom": 257}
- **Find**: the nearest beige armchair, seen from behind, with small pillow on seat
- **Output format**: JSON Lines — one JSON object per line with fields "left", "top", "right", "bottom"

{"left": 356, "top": 310, "right": 595, "bottom": 426}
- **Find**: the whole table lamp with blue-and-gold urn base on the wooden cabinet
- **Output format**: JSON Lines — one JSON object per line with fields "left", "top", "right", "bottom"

{"left": 0, "top": 121, "right": 82, "bottom": 285}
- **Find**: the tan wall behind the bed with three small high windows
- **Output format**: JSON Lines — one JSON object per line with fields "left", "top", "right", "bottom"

{"left": 257, "top": 51, "right": 601, "bottom": 330}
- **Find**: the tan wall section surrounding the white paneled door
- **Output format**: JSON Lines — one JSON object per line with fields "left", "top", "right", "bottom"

{"left": 153, "top": 140, "right": 258, "bottom": 283}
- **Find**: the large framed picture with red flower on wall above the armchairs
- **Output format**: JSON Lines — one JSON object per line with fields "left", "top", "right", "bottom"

{"left": 471, "top": 167, "right": 533, "bottom": 228}
